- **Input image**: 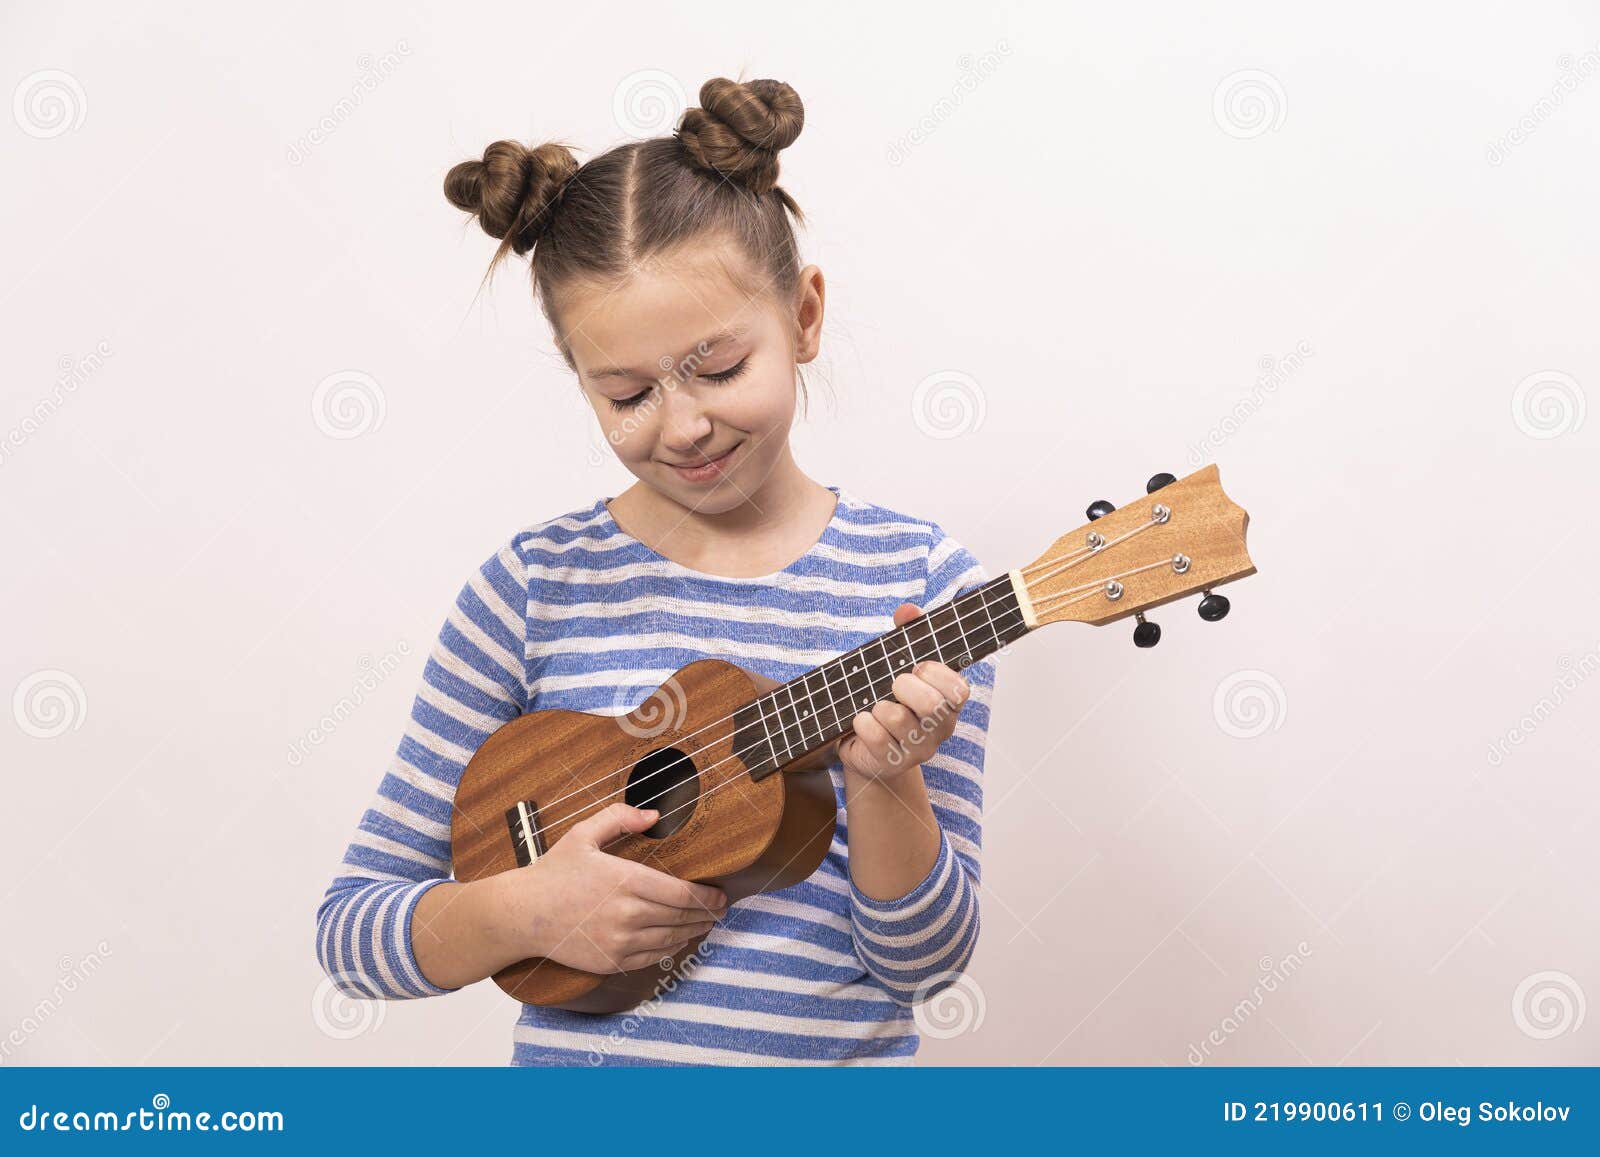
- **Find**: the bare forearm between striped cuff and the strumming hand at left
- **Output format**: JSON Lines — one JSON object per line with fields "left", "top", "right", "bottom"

{"left": 411, "top": 875, "right": 531, "bottom": 989}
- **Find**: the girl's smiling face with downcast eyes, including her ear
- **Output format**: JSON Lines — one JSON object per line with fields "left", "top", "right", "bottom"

{"left": 562, "top": 245, "right": 822, "bottom": 514}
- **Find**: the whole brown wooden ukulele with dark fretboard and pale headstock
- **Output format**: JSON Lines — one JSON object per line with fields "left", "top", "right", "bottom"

{"left": 450, "top": 466, "right": 1256, "bottom": 1013}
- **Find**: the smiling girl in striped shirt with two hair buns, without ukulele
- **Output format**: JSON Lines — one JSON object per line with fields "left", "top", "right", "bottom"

{"left": 317, "top": 80, "right": 994, "bottom": 1064}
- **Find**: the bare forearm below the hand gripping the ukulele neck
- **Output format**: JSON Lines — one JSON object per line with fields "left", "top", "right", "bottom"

{"left": 845, "top": 767, "right": 939, "bottom": 899}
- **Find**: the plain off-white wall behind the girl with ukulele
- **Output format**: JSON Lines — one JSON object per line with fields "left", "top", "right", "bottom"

{"left": 0, "top": 3, "right": 1600, "bottom": 1066}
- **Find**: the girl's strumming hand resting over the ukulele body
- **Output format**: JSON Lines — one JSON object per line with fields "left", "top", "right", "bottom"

{"left": 501, "top": 802, "right": 728, "bottom": 973}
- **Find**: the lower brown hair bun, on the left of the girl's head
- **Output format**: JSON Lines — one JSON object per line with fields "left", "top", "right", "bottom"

{"left": 445, "top": 141, "right": 578, "bottom": 256}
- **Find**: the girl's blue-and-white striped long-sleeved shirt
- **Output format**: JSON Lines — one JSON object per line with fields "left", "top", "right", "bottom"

{"left": 317, "top": 486, "right": 994, "bottom": 1066}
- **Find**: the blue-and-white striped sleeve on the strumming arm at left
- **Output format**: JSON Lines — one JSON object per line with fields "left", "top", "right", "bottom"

{"left": 317, "top": 541, "right": 528, "bottom": 1000}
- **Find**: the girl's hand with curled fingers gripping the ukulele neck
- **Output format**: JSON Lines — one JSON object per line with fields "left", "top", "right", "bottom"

{"left": 838, "top": 603, "right": 971, "bottom": 779}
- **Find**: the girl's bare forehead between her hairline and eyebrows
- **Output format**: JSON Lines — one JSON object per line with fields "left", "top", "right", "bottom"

{"left": 562, "top": 250, "right": 765, "bottom": 378}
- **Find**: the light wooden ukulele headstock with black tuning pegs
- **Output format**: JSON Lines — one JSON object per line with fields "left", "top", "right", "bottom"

{"left": 1016, "top": 466, "right": 1256, "bottom": 647}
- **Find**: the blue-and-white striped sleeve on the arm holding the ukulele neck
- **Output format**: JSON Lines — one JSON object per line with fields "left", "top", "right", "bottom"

{"left": 850, "top": 526, "right": 995, "bottom": 1007}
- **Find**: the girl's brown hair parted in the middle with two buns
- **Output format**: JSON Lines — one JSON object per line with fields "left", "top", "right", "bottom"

{"left": 445, "top": 77, "right": 805, "bottom": 377}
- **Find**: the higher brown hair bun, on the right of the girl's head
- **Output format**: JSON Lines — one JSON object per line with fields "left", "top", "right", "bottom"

{"left": 677, "top": 77, "right": 805, "bottom": 195}
